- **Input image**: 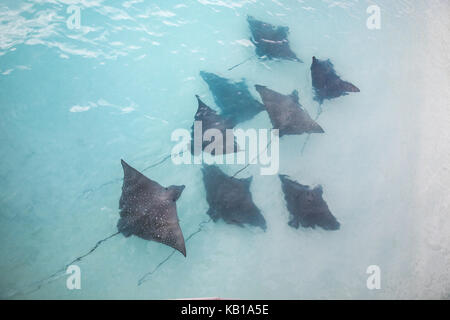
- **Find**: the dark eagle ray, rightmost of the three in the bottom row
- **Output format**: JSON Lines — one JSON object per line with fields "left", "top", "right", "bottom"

{"left": 279, "top": 175, "right": 340, "bottom": 230}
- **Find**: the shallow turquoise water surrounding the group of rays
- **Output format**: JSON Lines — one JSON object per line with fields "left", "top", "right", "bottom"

{"left": 0, "top": 0, "right": 442, "bottom": 299}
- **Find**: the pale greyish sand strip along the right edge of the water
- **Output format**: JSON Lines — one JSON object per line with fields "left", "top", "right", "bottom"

{"left": 410, "top": 0, "right": 450, "bottom": 299}
